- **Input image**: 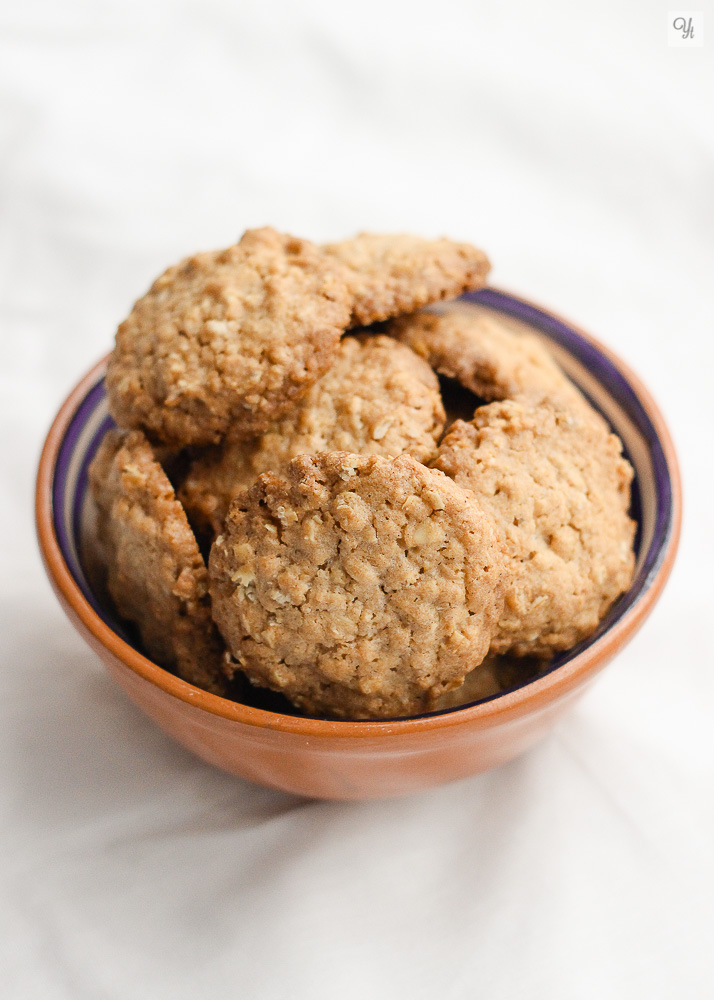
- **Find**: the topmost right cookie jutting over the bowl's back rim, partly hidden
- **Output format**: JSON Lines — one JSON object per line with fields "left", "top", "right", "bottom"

{"left": 323, "top": 233, "right": 491, "bottom": 326}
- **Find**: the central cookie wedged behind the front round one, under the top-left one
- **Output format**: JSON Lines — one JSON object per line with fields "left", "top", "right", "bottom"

{"left": 179, "top": 334, "right": 444, "bottom": 535}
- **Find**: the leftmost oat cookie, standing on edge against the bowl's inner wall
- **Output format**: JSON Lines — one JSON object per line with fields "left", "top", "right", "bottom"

{"left": 89, "top": 431, "right": 227, "bottom": 694}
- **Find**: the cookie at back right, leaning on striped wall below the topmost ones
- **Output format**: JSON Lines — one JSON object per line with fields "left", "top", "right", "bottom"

{"left": 386, "top": 305, "right": 598, "bottom": 420}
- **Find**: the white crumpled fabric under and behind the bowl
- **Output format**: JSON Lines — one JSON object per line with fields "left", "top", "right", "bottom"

{"left": 0, "top": 0, "right": 714, "bottom": 1000}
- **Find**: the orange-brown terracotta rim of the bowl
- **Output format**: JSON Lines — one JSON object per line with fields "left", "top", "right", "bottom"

{"left": 35, "top": 286, "right": 682, "bottom": 740}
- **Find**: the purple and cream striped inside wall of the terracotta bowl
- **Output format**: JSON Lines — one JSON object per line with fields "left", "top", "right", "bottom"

{"left": 52, "top": 288, "right": 674, "bottom": 714}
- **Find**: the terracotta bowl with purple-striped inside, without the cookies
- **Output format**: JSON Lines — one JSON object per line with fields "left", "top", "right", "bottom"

{"left": 36, "top": 289, "right": 681, "bottom": 799}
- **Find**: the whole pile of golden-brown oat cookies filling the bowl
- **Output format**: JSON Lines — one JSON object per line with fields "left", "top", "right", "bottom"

{"left": 90, "top": 229, "right": 634, "bottom": 718}
